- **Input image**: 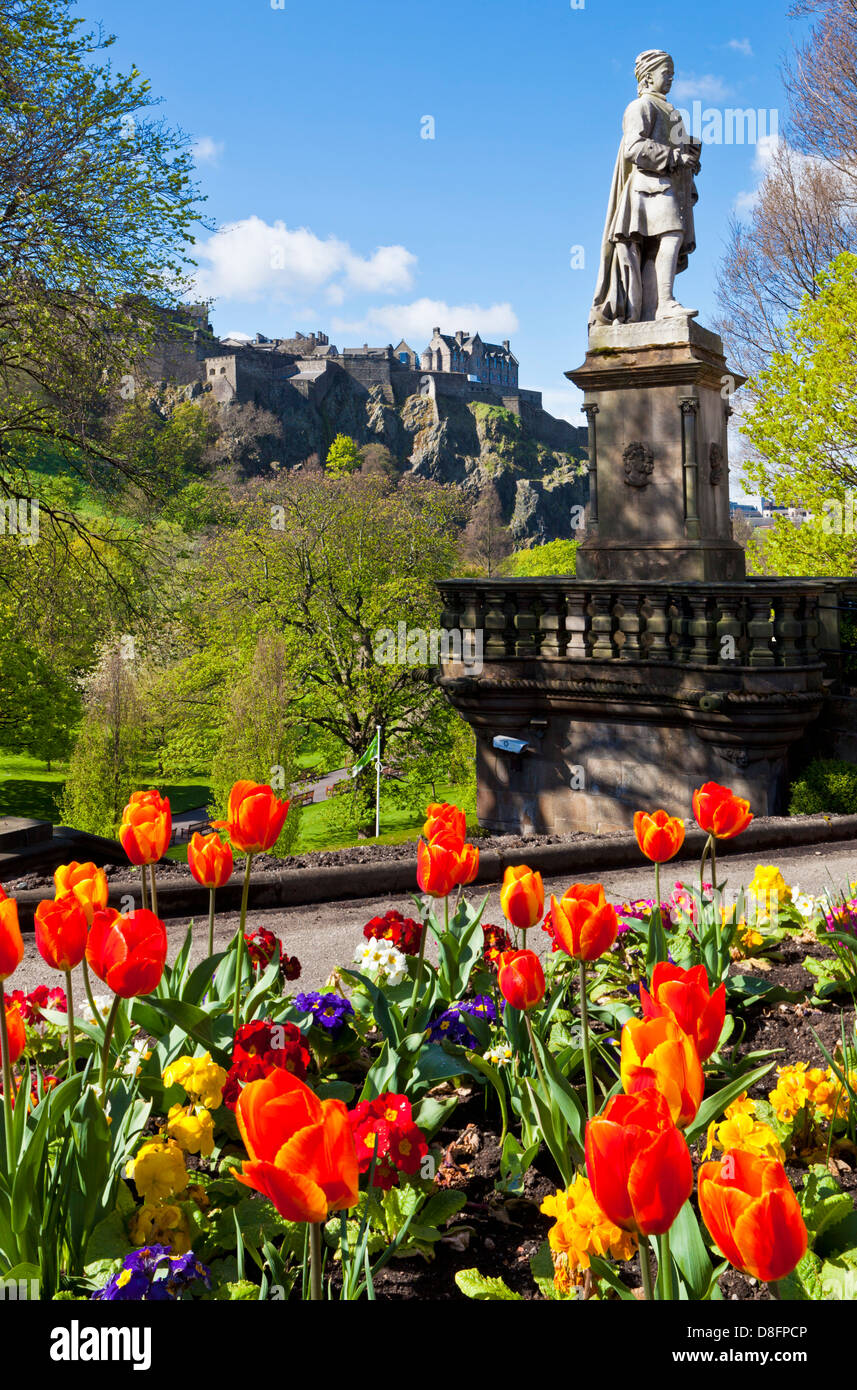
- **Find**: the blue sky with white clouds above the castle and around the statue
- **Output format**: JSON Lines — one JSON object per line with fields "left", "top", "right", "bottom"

{"left": 91, "top": 0, "right": 797, "bottom": 421}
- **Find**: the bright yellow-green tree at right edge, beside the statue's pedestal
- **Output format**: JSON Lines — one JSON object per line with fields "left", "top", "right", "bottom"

{"left": 742, "top": 253, "right": 857, "bottom": 575}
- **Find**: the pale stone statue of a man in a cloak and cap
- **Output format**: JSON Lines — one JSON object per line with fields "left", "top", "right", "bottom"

{"left": 589, "top": 49, "right": 701, "bottom": 325}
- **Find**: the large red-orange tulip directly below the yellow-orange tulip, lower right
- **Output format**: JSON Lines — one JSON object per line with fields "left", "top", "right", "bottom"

{"left": 586, "top": 1087, "right": 693, "bottom": 1236}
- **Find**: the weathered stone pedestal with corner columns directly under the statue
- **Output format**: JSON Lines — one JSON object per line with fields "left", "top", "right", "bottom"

{"left": 565, "top": 318, "right": 744, "bottom": 582}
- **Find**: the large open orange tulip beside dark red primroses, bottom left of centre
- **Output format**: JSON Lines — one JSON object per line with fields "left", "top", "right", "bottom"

{"left": 235, "top": 1068, "right": 360, "bottom": 1222}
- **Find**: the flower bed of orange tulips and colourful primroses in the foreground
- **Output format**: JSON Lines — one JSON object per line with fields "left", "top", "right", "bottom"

{"left": 0, "top": 783, "right": 857, "bottom": 1302}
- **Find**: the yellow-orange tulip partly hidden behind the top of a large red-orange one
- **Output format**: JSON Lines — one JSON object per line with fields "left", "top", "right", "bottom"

{"left": 619, "top": 1016, "right": 706, "bottom": 1129}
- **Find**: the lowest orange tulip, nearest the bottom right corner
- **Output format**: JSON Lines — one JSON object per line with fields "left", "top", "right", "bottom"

{"left": 699, "top": 1150, "right": 807, "bottom": 1283}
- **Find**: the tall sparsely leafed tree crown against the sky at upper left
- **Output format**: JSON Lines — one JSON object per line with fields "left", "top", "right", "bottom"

{"left": 0, "top": 0, "right": 199, "bottom": 521}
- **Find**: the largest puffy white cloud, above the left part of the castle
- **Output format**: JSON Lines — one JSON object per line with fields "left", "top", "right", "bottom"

{"left": 196, "top": 217, "right": 417, "bottom": 303}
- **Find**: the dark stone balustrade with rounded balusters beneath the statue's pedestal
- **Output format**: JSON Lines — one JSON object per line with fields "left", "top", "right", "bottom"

{"left": 440, "top": 577, "right": 857, "bottom": 670}
